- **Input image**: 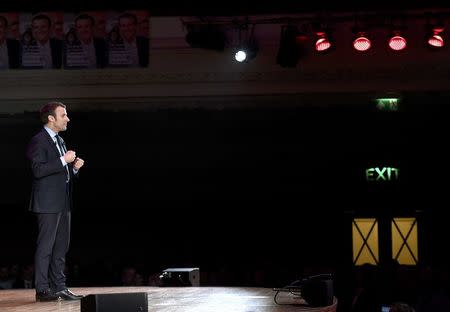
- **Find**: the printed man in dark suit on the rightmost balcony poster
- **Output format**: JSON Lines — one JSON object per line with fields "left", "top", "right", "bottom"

{"left": 118, "top": 12, "right": 150, "bottom": 67}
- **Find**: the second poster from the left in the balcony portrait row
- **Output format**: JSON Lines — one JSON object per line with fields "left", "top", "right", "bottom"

{"left": 20, "top": 12, "right": 63, "bottom": 69}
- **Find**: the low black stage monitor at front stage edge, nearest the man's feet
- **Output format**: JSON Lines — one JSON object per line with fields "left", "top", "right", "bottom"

{"left": 81, "top": 292, "right": 148, "bottom": 312}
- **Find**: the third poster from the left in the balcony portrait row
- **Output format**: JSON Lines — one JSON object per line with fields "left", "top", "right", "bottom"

{"left": 64, "top": 12, "right": 107, "bottom": 68}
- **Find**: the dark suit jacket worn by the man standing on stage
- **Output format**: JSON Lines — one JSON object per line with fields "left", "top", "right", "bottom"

{"left": 27, "top": 129, "right": 73, "bottom": 213}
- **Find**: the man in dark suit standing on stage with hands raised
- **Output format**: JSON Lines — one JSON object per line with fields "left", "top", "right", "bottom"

{"left": 27, "top": 102, "right": 84, "bottom": 301}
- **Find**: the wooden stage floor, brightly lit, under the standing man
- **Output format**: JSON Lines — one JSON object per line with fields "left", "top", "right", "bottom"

{"left": 0, "top": 287, "right": 337, "bottom": 312}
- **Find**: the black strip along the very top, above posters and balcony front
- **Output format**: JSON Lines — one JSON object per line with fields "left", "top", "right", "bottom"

{"left": 0, "top": 0, "right": 450, "bottom": 16}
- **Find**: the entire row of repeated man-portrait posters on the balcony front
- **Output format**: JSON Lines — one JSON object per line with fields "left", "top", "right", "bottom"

{"left": 0, "top": 10, "right": 150, "bottom": 70}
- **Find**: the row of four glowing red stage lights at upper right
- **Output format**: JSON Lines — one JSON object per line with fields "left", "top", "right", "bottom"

{"left": 315, "top": 28, "right": 445, "bottom": 52}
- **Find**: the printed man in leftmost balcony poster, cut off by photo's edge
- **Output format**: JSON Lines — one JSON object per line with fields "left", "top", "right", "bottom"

{"left": 0, "top": 15, "right": 20, "bottom": 69}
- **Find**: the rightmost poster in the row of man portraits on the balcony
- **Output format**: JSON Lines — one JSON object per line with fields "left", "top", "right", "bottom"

{"left": 107, "top": 11, "right": 150, "bottom": 67}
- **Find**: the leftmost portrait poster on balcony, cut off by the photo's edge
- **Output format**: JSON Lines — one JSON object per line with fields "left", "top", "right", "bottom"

{"left": 0, "top": 13, "right": 20, "bottom": 70}
